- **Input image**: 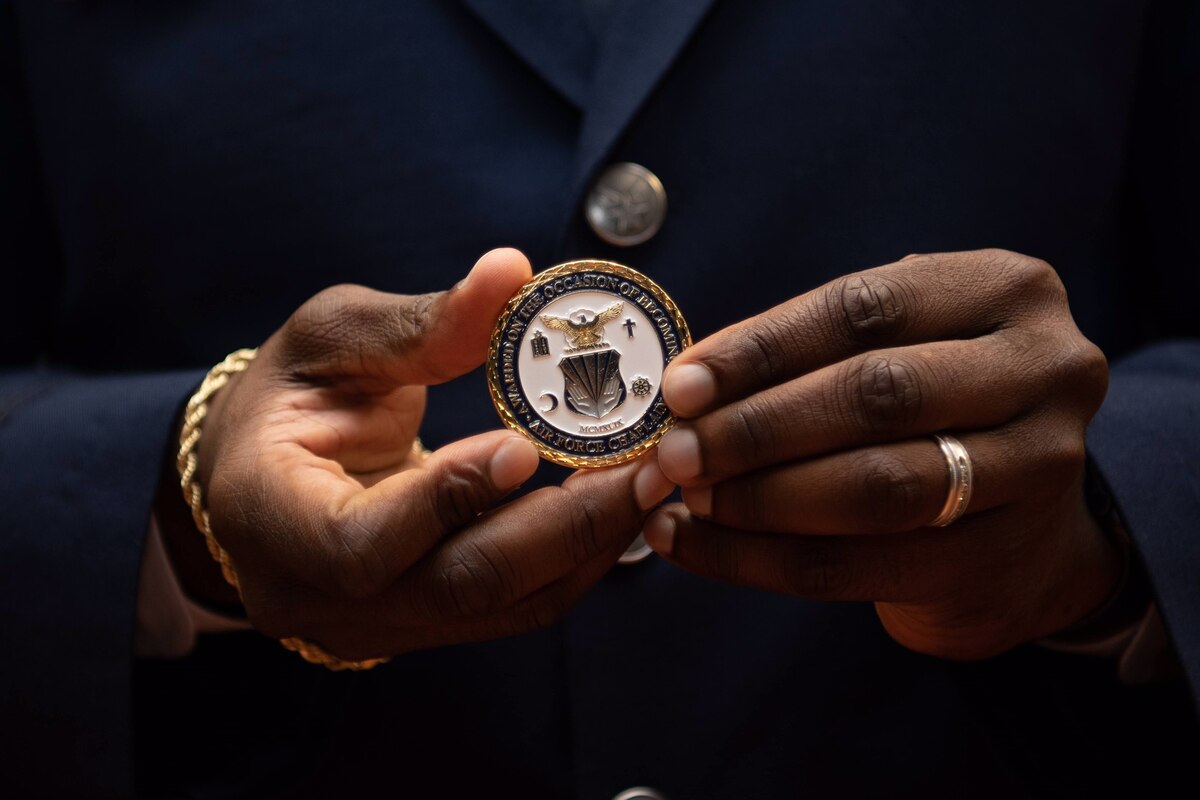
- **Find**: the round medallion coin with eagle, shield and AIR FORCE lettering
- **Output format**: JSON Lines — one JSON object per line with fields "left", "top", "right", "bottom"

{"left": 487, "top": 261, "right": 691, "bottom": 468}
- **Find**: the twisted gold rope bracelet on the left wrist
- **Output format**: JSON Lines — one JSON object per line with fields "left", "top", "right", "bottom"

{"left": 175, "top": 349, "right": 388, "bottom": 672}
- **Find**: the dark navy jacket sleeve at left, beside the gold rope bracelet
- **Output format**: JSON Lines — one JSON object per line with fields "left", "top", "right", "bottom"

{"left": 0, "top": 372, "right": 203, "bottom": 796}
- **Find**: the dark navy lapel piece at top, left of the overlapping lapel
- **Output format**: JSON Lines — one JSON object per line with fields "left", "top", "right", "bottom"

{"left": 462, "top": 0, "right": 596, "bottom": 109}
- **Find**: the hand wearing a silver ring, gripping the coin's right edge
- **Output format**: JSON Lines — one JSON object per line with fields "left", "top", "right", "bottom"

{"left": 646, "top": 251, "right": 1121, "bottom": 660}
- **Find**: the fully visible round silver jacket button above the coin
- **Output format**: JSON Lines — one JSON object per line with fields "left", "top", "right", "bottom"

{"left": 584, "top": 162, "right": 667, "bottom": 247}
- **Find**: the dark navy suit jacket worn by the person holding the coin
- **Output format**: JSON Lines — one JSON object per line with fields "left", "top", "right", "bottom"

{"left": 0, "top": 0, "right": 1200, "bottom": 800}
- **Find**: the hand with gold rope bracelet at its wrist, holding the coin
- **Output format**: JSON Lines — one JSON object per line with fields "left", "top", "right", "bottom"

{"left": 162, "top": 249, "right": 673, "bottom": 660}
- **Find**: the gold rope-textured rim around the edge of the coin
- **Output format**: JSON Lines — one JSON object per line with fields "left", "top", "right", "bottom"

{"left": 487, "top": 259, "right": 691, "bottom": 469}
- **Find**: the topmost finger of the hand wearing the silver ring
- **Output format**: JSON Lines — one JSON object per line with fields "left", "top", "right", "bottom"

{"left": 662, "top": 249, "right": 1062, "bottom": 417}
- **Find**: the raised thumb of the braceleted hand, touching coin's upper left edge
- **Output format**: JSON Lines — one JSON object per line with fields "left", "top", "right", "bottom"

{"left": 282, "top": 247, "right": 533, "bottom": 385}
